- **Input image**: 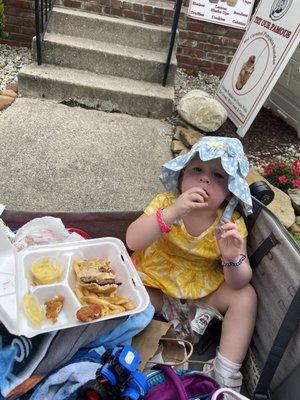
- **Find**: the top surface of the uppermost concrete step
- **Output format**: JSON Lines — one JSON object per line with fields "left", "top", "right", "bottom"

{"left": 53, "top": 3, "right": 174, "bottom": 33}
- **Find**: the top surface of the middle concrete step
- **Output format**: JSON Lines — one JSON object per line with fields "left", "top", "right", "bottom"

{"left": 44, "top": 33, "right": 177, "bottom": 65}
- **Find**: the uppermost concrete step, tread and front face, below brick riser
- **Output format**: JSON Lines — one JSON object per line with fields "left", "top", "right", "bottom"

{"left": 47, "top": 7, "right": 175, "bottom": 51}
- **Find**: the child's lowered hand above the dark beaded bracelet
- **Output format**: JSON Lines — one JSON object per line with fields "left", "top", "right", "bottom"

{"left": 215, "top": 218, "right": 243, "bottom": 261}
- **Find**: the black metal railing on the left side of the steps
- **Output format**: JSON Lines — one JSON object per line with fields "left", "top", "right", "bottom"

{"left": 35, "top": 0, "right": 55, "bottom": 65}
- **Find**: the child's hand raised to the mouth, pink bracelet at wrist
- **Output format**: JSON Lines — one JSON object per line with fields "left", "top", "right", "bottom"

{"left": 171, "top": 187, "right": 208, "bottom": 218}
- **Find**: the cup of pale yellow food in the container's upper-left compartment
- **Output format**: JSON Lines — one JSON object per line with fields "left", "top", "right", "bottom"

{"left": 30, "top": 258, "right": 62, "bottom": 285}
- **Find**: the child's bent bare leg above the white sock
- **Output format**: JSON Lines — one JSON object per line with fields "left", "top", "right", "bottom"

{"left": 203, "top": 282, "right": 257, "bottom": 364}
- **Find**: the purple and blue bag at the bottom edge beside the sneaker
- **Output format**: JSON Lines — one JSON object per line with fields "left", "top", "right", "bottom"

{"left": 145, "top": 365, "right": 222, "bottom": 400}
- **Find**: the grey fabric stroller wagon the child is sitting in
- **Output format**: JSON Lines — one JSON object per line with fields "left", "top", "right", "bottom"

{"left": 2, "top": 192, "right": 300, "bottom": 400}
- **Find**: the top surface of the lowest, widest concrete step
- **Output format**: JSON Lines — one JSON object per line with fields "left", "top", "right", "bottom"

{"left": 19, "top": 63, "right": 174, "bottom": 99}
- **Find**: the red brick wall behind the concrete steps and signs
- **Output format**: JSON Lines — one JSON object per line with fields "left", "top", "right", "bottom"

{"left": 0, "top": 0, "right": 244, "bottom": 76}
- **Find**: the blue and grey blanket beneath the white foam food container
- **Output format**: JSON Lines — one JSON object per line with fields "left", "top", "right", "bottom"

{"left": 0, "top": 306, "right": 154, "bottom": 400}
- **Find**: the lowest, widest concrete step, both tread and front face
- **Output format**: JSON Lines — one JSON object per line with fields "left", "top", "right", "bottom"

{"left": 18, "top": 64, "right": 174, "bottom": 118}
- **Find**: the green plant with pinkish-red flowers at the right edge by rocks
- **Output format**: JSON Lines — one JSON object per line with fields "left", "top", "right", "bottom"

{"left": 263, "top": 160, "right": 300, "bottom": 192}
